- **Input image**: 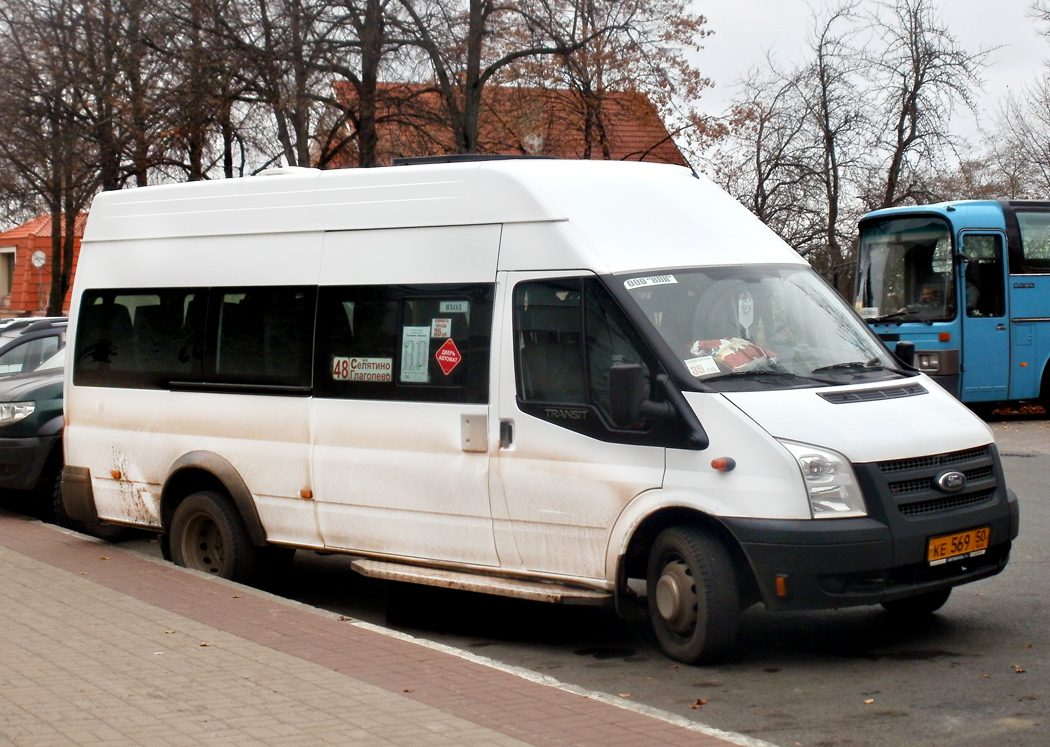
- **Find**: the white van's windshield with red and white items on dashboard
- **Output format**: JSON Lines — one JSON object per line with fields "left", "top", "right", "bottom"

{"left": 621, "top": 265, "right": 900, "bottom": 390}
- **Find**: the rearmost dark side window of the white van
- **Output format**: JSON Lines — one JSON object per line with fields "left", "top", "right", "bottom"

{"left": 74, "top": 288, "right": 207, "bottom": 389}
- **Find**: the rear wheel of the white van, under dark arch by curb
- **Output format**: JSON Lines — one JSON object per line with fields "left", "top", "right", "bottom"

{"left": 171, "top": 491, "right": 256, "bottom": 583}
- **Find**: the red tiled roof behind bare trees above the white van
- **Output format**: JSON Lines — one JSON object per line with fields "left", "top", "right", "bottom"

{"left": 333, "top": 83, "right": 687, "bottom": 166}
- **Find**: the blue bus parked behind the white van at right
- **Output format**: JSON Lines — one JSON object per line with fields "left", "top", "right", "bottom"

{"left": 854, "top": 200, "right": 1050, "bottom": 410}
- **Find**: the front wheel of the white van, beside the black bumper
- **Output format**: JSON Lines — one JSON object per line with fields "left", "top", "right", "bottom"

{"left": 646, "top": 526, "right": 740, "bottom": 664}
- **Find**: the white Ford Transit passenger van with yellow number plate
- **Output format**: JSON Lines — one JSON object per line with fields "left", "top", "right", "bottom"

{"left": 63, "top": 160, "right": 1017, "bottom": 662}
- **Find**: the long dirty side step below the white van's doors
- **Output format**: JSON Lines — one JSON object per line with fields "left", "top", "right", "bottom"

{"left": 350, "top": 558, "right": 613, "bottom": 605}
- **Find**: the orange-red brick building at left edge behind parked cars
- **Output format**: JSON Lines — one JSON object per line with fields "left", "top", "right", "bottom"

{"left": 0, "top": 213, "right": 87, "bottom": 316}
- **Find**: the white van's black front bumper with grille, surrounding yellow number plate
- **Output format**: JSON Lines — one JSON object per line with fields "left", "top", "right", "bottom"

{"left": 722, "top": 445, "right": 1020, "bottom": 609}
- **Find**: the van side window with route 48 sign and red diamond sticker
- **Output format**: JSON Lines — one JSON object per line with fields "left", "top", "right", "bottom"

{"left": 314, "top": 285, "right": 492, "bottom": 403}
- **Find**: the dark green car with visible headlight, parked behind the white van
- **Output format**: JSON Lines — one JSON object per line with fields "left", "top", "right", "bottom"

{"left": 0, "top": 349, "right": 65, "bottom": 518}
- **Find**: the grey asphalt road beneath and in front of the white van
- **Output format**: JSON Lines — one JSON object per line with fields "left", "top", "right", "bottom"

{"left": 6, "top": 416, "right": 1050, "bottom": 747}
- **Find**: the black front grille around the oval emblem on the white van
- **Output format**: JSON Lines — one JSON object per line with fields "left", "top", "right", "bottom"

{"left": 877, "top": 447, "right": 999, "bottom": 518}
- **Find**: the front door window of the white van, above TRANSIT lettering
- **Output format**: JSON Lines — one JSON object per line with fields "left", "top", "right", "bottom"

{"left": 515, "top": 278, "right": 652, "bottom": 432}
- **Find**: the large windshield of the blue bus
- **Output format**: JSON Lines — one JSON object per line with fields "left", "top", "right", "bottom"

{"left": 855, "top": 215, "right": 956, "bottom": 324}
